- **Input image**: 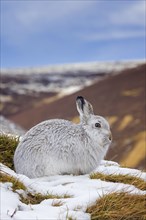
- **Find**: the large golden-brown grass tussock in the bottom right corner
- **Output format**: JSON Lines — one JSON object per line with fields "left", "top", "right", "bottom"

{"left": 87, "top": 193, "right": 146, "bottom": 220}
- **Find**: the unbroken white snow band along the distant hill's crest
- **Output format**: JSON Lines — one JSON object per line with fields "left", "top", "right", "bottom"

{"left": 1, "top": 60, "right": 145, "bottom": 75}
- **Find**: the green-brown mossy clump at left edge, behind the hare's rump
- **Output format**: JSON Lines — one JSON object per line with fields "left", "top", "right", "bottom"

{"left": 0, "top": 135, "right": 19, "bottom": 169}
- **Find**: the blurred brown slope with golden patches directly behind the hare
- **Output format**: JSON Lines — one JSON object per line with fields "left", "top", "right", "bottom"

{"left": 9, "top": 64, "right": 146, "bottom": 169}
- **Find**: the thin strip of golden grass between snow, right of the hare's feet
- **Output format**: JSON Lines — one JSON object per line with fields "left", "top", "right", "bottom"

{"left": 90, "top": 173, "right": 146, "bottom": 190}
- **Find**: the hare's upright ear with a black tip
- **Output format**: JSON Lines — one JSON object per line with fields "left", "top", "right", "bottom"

{"left": 76, "top": 96, "right": 94, "bottom": 123}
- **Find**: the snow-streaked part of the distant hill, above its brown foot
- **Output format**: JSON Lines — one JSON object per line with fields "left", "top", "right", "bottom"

{"left": 1, "top": 60, "right": 145, "bottom": 96}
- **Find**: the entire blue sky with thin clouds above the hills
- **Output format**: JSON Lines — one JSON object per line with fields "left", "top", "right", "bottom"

{"left": 1, "top": 0, "right": 146, "bottom": 68}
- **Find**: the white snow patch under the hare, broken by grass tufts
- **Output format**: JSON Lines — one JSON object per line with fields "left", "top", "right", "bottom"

{"left": 1, "top": 160, "right": 146, "bottom": 220}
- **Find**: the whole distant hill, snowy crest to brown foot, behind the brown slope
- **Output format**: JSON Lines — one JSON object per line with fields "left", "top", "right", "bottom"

{"left": 0, "top": 60, "right": 141, "bottom": 117}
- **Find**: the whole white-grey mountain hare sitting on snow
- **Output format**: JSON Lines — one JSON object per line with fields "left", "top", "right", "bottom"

{"left": 14, "top": 96, "right": 111, "bottom": 178}
